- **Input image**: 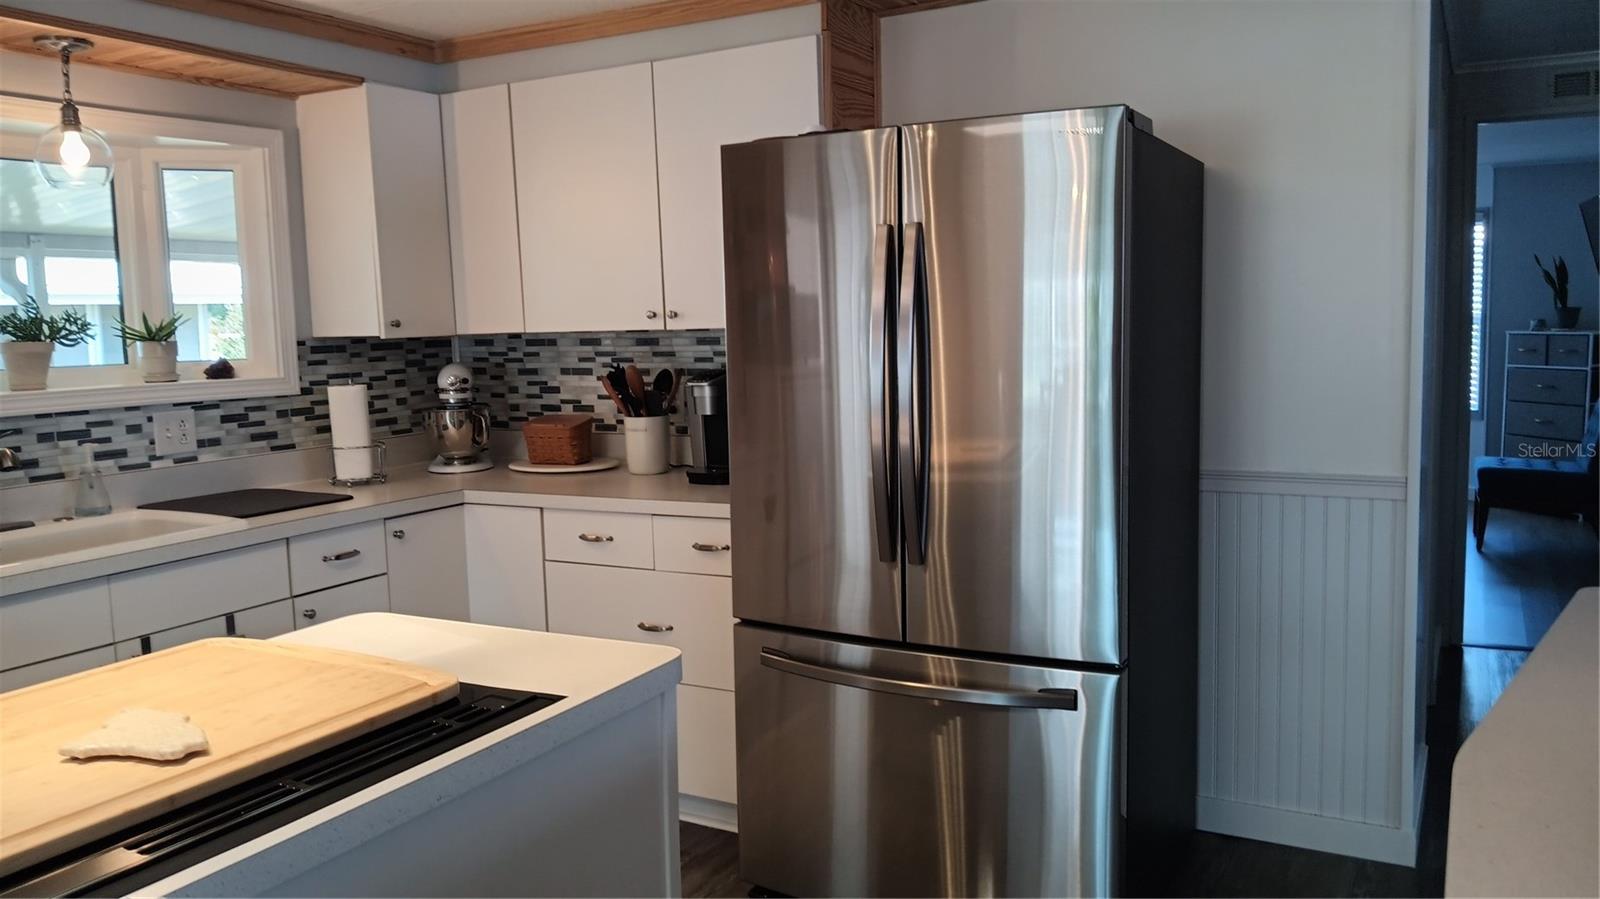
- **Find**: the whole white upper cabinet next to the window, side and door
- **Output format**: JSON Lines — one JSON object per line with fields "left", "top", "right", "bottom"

{"left": 296, "top": 85, "right": 456, "bottom": 338}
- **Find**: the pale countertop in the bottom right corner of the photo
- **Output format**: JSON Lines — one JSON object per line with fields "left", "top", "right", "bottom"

{"left": 1445, "top": 587, "right": 1600, "bottom": 896}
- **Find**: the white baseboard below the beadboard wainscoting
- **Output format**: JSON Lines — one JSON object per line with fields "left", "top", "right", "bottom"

{"left": 1195, "top": 797, "right": 1416, "bottom": 867}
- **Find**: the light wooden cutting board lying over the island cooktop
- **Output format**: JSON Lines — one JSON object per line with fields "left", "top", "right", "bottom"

{"left": 0, "top": 638, "right": 459, "bottom": 875}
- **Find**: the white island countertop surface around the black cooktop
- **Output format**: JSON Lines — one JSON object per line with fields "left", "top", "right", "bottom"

{"left": 139, "top": 613, "right": 682, "bottom": 896}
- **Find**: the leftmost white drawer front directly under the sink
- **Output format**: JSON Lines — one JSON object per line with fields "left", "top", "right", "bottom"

{"left": 0, "top": 577, "right": 114, "bottom": 669}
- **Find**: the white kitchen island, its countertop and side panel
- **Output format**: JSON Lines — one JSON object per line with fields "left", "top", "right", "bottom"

{"left": 139, "top": 613, "right": 680, "bottom": 896}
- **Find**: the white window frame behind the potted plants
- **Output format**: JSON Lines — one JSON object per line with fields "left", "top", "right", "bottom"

{"left": 0, "top": 94, "right": 301, "bottom": 416}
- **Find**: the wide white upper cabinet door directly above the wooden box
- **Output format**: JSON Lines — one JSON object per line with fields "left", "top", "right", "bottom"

{"left": 510, "top": 62, "right": 662, "bottom": 331}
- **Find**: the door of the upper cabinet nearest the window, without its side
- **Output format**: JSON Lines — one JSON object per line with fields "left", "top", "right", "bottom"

{"left": 366, "top": 85, "right": 456, "bottom": 338}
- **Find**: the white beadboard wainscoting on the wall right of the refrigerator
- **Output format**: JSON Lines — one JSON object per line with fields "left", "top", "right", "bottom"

{"left": 1197, "top": 472, "right": 1416, "bottom": 865}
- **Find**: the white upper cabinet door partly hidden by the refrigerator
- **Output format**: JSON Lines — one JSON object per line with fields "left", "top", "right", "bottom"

{"left": 654, "top": 37, "right": 821, "bottom": 328}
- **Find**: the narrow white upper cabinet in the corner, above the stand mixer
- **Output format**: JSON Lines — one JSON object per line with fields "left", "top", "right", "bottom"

{"left": 440, "top": 85, "right": 526, "bottom": 334}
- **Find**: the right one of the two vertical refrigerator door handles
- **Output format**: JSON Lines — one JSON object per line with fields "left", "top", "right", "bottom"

{"left": 894, "top": 222, "right": 928, "bottom": 565}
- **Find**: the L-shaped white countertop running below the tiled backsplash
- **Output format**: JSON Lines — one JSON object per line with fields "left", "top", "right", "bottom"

{"left": 0, "top": 464, "right": 730, "bottom": 595}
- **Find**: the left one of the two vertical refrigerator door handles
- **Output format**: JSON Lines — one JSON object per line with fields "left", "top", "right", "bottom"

{"left": 867, "top": 224, "right": 899, "bottom": 561}
